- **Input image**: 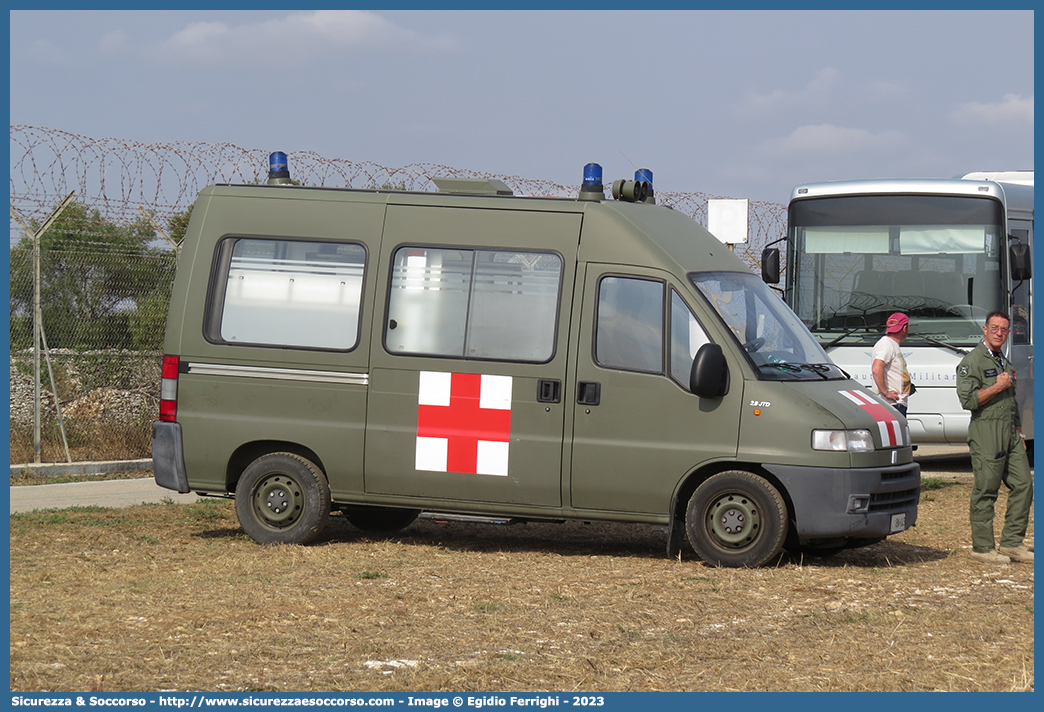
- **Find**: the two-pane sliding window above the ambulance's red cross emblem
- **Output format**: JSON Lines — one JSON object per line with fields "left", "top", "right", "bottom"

{"left": 384, "top": 247, "right": 562, "bottom": 363}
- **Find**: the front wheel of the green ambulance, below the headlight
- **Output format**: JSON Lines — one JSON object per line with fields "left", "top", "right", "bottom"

{"left": 685, "top": 471, "right": 787, "bottom": 567}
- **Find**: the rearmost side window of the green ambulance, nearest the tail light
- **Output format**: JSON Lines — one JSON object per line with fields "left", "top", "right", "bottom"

{"left": 208, "top": 238, "right": 366, "bottom": 351}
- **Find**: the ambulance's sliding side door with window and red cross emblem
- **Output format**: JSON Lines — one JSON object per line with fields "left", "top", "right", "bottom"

{"left": 365, "top": 206, "right": 580, "bottom": 511}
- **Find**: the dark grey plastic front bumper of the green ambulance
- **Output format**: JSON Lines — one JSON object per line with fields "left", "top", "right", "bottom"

{"left": 762, "top": 462, "right": 921, "bottom": 542}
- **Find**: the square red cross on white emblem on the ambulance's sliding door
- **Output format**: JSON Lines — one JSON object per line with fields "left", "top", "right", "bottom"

{"left": 417, "top": 371, "right": 512, "bottom": 476}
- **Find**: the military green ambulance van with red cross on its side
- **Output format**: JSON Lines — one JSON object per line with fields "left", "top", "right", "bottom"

{"left": 152, "top": 153, "right": 920, "bottom": 566}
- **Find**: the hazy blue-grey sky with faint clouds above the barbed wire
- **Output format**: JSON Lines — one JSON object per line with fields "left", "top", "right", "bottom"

{"left": 10, "top": 10, "right": 1034, "bottom": 203}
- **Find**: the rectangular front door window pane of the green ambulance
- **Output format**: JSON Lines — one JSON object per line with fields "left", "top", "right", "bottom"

{"left": 594, "top": 277, "right": 659, "bottom": 371}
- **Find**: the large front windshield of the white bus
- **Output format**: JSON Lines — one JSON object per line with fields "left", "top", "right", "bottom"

{"left": 787, "top": 194, "right": 1004, "bottom": 348}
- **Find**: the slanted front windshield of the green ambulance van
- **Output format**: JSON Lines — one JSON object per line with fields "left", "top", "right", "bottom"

{"left": 689, "top": 271, "right": 848, "bottom": 381}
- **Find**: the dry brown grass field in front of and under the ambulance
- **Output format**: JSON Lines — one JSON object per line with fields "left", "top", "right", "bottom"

{"left": 10, "top": 473, "right": 1034, "bottom": 692}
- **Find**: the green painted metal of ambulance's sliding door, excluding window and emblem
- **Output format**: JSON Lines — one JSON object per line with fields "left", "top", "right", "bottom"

{"left": 365, "top": 202, "right": 582, "bottom": 507}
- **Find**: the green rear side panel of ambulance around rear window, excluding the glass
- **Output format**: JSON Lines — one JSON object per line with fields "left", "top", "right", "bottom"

{"left": 164, "top": 186, "right": 385, "bottom": 490}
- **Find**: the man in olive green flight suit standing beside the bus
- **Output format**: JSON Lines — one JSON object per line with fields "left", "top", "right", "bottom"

{"left": 957, "top": 311, "right": 1034, "bottom": 564}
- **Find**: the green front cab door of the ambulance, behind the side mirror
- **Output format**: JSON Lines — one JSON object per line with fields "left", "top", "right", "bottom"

{"left": 570, "top": 264, "right": 742, "bottom": 515}
